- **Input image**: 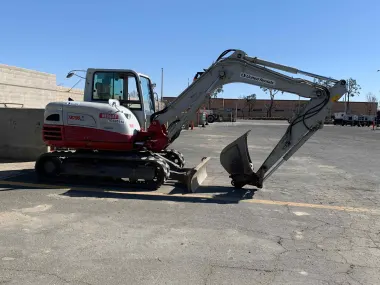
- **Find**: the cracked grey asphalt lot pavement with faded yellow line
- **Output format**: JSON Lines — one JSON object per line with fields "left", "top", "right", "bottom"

{"left": 0, "top": 121, "right": 380, "bottom": 285}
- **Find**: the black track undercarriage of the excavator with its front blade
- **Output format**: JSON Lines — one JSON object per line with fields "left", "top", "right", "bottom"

{"left": 35, "top": 150, "right": 208, "bottom": 192}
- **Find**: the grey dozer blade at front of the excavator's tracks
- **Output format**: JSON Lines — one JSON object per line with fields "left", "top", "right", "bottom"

{"left": 170, "top": 157, "right": 210, "bottom": 193}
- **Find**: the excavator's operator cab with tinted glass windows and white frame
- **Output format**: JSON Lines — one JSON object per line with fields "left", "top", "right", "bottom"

{"left": 84, "top": 68, "right": 156, "bottom": 130}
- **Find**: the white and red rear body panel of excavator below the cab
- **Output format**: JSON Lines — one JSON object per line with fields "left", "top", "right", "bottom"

{"left": 44, "top": 102, "right": 140, "bottom": 150}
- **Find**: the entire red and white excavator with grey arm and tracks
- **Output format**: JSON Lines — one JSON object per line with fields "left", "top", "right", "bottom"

{"left": 35, "top": 49, "right": 347, "bottom": 192}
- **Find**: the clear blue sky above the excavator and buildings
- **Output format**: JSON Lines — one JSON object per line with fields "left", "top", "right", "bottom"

{"left": 0, "top": 0, "right": 380, "bottom": 101}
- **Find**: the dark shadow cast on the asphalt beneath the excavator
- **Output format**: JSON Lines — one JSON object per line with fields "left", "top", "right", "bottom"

{"left": 0, "top": 169, "right": 256, "bottom": 204}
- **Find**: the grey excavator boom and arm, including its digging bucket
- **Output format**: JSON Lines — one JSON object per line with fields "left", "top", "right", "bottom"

{"left": 151, "top": 50, "right": 347, "bottom": 188}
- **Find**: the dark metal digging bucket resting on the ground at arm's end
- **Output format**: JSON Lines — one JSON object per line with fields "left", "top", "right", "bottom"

{"left": 220, "top": 130, "right": 262, "bottom": 188}
